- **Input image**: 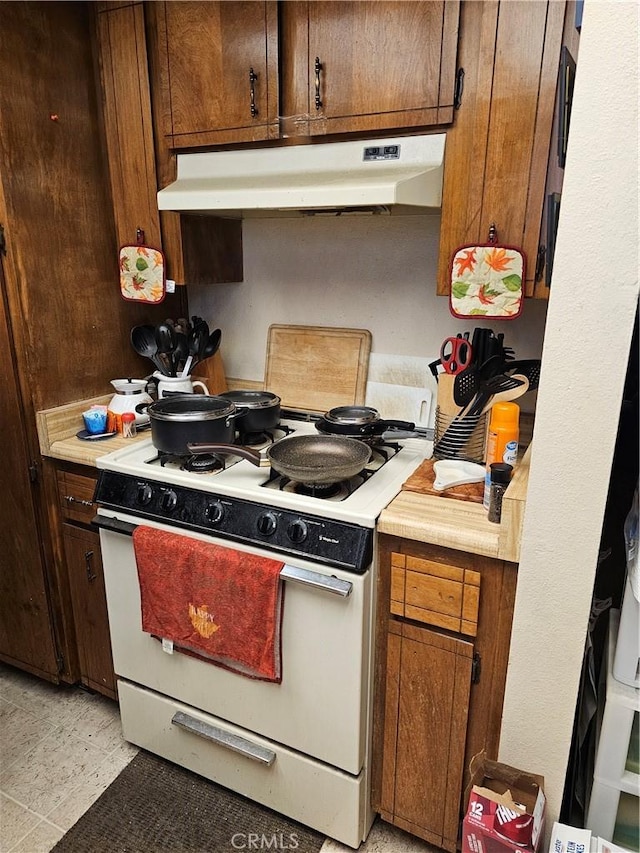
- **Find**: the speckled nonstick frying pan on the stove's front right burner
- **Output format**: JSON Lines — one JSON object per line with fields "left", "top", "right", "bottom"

{"left": 187, "top": 435, "right": 371, "bottom": 484}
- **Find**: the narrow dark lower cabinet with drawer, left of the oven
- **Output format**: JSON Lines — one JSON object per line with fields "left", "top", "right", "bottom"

{"left": 57, "top": 470, "right": 117, "bottom": 699}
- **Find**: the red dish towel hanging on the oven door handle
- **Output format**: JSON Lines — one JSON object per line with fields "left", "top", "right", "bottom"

{"left": 133, "top": 525, "right": 284, "bottom": 683}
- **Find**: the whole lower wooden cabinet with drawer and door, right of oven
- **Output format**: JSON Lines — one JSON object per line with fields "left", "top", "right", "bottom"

{"left": 372, "top": 535, "right": 517, "bottom": 851}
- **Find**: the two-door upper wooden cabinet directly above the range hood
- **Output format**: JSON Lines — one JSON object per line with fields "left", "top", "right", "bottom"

{"left": 150, "top": 0, "right": 460, "bottom": 148}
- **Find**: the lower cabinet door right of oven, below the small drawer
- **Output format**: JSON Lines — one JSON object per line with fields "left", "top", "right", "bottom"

{"left": 380, "top": 622, "right": 473, "bottom": 850}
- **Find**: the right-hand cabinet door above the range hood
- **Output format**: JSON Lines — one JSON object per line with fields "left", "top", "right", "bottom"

{"left": 298, "top": 0, "right": 460, "bottom": 134}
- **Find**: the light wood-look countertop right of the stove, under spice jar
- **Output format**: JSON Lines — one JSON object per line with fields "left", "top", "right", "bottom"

{"left": 377, "top": 445, "right": 531, "bottom": 563}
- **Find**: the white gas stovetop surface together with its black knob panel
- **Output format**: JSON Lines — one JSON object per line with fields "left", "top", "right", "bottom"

{"left": 95, "top": 414, "right": 432, "bottom": 570}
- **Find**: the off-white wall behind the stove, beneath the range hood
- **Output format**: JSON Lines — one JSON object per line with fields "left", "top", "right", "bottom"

{"left": 189, "top": 215, "right": 546, "bottom": 396}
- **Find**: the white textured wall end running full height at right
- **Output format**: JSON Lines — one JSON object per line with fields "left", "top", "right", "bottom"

{"left": 500, "top": 0, "right": 639, "bottom": 827}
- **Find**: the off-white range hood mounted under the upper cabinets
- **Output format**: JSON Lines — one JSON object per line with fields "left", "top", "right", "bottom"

{"left": 158, "top": 134, "right": 445, "bottom": 216}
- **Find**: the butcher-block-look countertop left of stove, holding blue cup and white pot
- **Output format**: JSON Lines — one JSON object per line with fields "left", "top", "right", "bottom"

{"left": 36, "top": 394, "right": 148, "bottom": 468}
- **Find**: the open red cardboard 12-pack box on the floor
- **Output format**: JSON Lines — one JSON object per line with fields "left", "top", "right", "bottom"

{"left": 462, "top": 753, "right": 545, "bottom": 853}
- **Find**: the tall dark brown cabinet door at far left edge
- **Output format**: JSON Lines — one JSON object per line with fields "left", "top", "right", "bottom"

{"left": 0, "top": 266, "right": 58, "bottom": 677}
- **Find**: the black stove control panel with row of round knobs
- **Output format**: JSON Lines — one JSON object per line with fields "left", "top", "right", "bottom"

{"left": 94, "top": 471, "right": 373, "bottom": 574}
